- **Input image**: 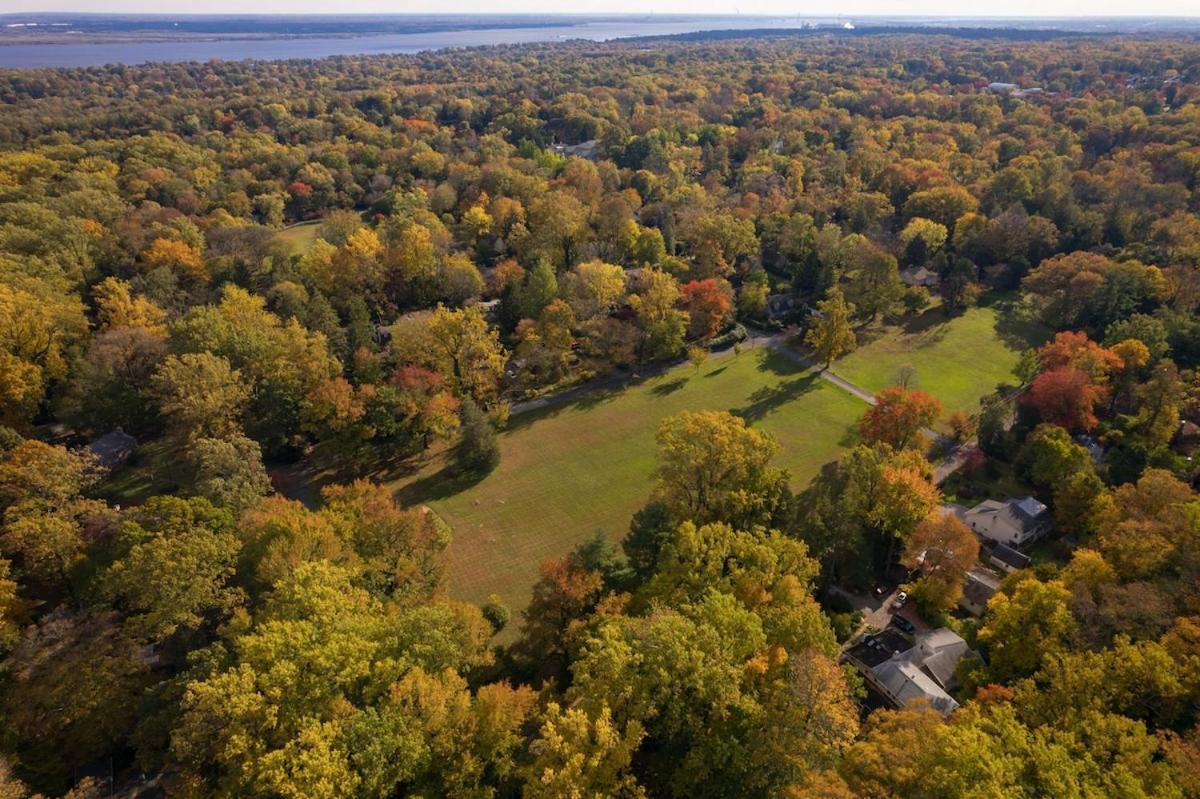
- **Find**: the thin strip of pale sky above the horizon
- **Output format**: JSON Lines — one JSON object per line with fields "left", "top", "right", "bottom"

{"left": 0, "top": 0, "right": 1200, "bottom": 18}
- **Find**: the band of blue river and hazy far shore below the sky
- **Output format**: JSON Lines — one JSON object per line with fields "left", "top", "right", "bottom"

{"left": 0, "top": 14, "right": 1200, "bottom": 70}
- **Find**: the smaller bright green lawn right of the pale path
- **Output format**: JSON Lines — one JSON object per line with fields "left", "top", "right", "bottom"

{"left": 833, "top": 307, "right": 1048, "bottom": 416}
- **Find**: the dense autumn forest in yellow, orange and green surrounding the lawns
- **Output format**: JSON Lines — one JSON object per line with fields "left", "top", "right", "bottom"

{"left": 0, "top": 34, "right": 1200, "bottom": 799}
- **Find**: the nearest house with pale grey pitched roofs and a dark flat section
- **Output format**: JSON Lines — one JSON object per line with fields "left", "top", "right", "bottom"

{"left": 844, "top": 627, "right": 971, "bottom": 715}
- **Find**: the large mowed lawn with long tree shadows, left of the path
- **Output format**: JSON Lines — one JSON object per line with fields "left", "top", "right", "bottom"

{"left": 395, "top": 349, "right": 866, "bottom": 614}
